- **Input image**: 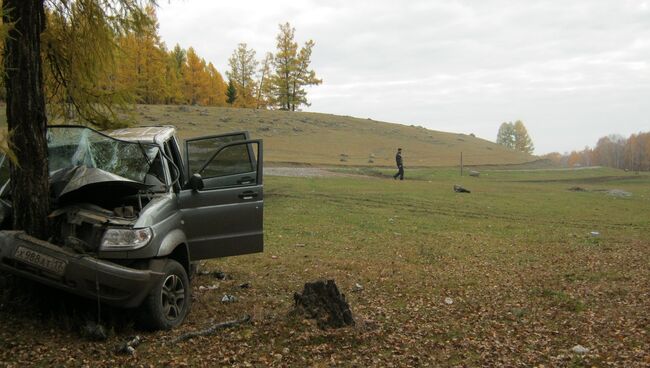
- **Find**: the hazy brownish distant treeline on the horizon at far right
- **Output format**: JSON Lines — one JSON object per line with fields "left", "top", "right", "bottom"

{"left": 544, "top": 132, "right": 650, "bottom": 171}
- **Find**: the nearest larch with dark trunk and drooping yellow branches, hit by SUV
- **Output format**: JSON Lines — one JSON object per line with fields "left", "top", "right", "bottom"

{"left": 2, "top": 0, "right": 147, "bottom": 239}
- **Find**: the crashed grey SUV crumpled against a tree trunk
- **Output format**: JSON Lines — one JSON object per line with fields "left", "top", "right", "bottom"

{"left": 0, "top": 126, "right": 263, "bottom": 329}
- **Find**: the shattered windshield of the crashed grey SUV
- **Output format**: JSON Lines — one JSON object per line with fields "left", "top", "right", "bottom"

{"left": 47, "top": 126, "right": 158, "bottom": 183}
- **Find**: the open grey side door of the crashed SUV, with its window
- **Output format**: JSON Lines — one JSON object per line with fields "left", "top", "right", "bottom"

{"left": 179, "top": 132, "right": 264, "bottom": 261}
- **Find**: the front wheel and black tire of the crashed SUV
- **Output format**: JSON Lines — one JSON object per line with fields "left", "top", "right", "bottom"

{"left": 140, "top": 259, "right": 192, "bottom": 330}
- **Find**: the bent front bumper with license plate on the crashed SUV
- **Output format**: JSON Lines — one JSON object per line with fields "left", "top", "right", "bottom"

{"left": 0, "top": 231, "right": 164, "bottom": 308}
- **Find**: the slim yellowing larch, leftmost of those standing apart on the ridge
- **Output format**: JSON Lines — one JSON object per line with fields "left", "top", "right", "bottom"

{"left": 226, "top": 43, "right": 258, "bottom": 107}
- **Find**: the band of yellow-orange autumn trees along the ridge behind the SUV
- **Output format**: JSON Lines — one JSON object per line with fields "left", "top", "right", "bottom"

{"left": 0, "top": 2, "right": 322, "bottom": 126}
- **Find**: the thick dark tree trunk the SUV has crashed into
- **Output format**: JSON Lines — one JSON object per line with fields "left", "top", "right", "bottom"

{"left": 3, "top": 0, "right": 50, "bottom": 239}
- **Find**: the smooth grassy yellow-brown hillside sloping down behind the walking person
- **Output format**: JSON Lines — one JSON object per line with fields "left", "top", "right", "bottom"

{"left": 136, "top": 105, "right": 535, "bottom": 167}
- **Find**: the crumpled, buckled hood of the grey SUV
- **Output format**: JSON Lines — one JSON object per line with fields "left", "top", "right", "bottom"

{"left": 50, "top": 166, "right": 149, "bottom": 200}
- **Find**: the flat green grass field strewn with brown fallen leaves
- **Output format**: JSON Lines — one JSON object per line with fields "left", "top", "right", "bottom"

{"left": 0, "top": 168, "right": 650, "bottom": 367}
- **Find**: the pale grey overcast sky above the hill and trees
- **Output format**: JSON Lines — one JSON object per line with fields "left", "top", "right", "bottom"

{"left": 158, "top": 0, "right": 650, "bottom": 154}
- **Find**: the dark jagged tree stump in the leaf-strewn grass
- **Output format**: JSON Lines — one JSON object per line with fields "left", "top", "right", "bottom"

{"left": 293, "top": 280, "right": 354, "bottom": 329}
